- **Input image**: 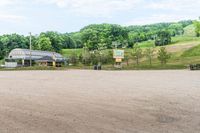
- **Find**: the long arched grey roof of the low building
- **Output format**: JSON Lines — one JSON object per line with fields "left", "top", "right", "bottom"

{"left": 8, "top": 49, "right": 64, "bottom": 61}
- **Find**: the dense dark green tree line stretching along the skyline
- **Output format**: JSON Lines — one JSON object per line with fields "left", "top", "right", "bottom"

{"left": 0, "top": 20, "right": 193, "bottom": 59}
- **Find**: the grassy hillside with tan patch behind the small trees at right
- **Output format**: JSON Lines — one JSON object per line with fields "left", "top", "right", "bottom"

{"left": 62, "top": 25, "right": 200, "bottom": 69}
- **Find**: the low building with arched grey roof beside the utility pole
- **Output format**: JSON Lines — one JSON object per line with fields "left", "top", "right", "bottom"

{"left": 5, "top": 49, "right": 65, "bottom": 67}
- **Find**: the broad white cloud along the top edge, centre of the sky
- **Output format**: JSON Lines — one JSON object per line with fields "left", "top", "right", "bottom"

{"left": 36, "top": 0, "right": 143, "bottom": 17}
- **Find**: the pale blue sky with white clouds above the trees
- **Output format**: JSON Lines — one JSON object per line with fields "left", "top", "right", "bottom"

{"left": 0, "top": 0, "right": 200, "bottom": 35}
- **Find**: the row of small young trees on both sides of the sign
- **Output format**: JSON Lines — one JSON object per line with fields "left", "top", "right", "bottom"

{"left": 68, "top": 44, "right": 171, "bottom": 66}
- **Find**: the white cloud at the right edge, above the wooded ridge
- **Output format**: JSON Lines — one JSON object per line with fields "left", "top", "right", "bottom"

{"left": 125, "top": 0, "right": 200, "bottom": 25}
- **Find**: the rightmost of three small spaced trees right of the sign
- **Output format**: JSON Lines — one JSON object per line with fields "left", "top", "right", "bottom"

{"left": 158, "top": 47, "right": 170, "bottom": 65}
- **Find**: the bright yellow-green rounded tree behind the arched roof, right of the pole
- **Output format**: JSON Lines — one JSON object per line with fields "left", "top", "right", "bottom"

{"left": 37, "top": 36, "right": 54, "bottom": 51}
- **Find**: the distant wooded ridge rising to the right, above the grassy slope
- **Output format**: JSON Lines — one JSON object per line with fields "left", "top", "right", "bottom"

{"left": 127, "top": 20, "right": 192, "bottom": 43}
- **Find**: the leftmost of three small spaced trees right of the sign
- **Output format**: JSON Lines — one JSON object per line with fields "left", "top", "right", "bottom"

{"left": 131, "top": 44, "right": 143, "bottom": 65}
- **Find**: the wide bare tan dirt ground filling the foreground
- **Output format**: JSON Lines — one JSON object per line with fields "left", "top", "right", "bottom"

{"left": 0, "top": 70, "right": 200, "bottom": 133}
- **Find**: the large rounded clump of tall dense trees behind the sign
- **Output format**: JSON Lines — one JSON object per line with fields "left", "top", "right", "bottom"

{"left": 80, "top": 24, "right": 128, "bottom": 51}
